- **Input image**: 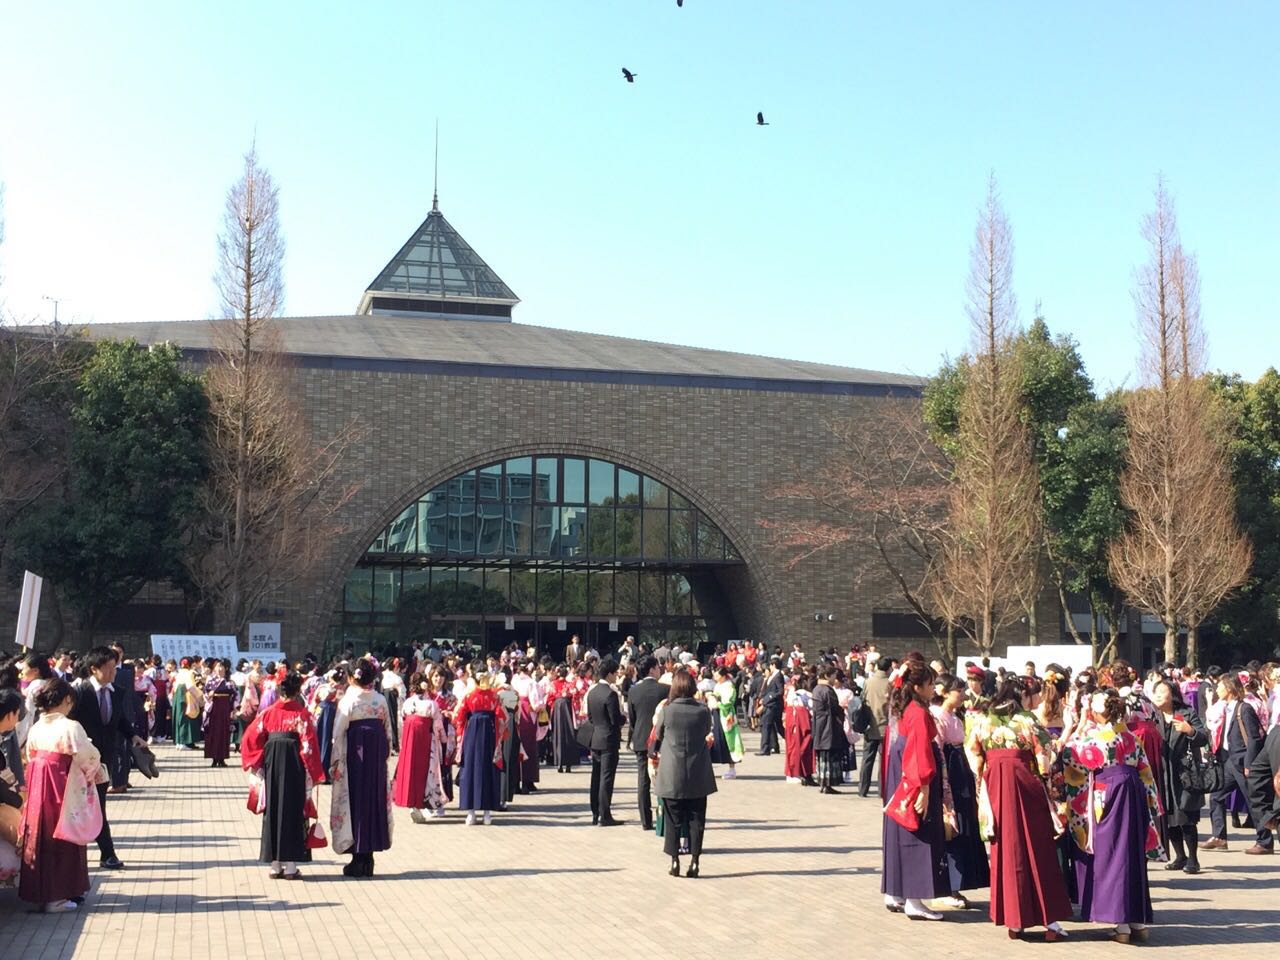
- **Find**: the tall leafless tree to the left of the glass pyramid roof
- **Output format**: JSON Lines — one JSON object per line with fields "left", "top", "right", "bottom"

{"left": 188, "top": 150, "right": 355, "bottom": 635}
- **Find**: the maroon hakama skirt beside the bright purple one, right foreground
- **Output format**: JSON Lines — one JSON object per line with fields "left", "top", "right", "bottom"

{"left": 986, "top": 750, "right": 1071, "bottom": 931}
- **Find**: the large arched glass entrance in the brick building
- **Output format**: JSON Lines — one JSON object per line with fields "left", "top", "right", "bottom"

{"left": 330, "top": 454, "right": 742, "bottom": 654}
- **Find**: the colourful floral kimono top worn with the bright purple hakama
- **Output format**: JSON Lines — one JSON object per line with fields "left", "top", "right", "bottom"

{"left": 1062, "top": 723, "right": 1164, "bottom": 860}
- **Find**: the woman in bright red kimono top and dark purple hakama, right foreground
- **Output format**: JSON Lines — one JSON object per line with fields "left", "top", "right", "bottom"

{"left": 881, "top": 657, "right": 951, "bottom": 920}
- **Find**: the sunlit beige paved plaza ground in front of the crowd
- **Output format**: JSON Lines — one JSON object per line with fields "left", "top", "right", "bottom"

{"left": 0, "top": 736, "right": 1280, "bottom": 960}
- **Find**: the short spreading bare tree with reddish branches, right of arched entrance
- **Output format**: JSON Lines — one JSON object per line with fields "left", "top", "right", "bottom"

{"left": 762, "top": 401, "right": 955, "bottom": 660}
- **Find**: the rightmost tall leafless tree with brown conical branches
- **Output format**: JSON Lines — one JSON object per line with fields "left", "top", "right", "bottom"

{"left": 1110, "top": 180, "right": 1252, "bottom": 663}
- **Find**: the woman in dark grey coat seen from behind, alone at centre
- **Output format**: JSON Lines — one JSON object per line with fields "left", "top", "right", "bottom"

{"left": 649, "top": 668, "right": 716, "bottom": 877}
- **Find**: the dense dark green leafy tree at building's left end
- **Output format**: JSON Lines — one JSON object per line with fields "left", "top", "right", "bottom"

{"left": 14, "top": 340, "right": 207, "bottom": 631}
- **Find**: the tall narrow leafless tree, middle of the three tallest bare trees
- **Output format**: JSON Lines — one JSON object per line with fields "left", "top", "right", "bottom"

{"left": 932, "top": 177, "right": 1042, "bottom": 653}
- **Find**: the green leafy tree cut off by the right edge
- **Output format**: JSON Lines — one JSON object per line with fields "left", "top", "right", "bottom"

{"left": 1206, "top": 367, "right": 1280, "bottom": 662}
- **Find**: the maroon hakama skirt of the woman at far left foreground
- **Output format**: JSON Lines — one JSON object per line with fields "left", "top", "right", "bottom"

{"left": 18, "top": 750, "right": 88, "bottom": 904}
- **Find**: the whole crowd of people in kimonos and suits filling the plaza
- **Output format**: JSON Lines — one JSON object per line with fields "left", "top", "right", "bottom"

{"left": 0, "top": 637, "right": 1280, "bottom": 942}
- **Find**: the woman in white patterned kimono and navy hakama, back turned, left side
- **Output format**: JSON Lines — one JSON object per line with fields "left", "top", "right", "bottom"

{"left": 329, "top": 660, "right": 394, "bottom": 877}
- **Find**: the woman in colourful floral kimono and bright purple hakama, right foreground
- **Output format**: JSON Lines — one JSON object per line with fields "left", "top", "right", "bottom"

{"left": 1062, "top": 689, "right": 1164, "bottom": 943}
